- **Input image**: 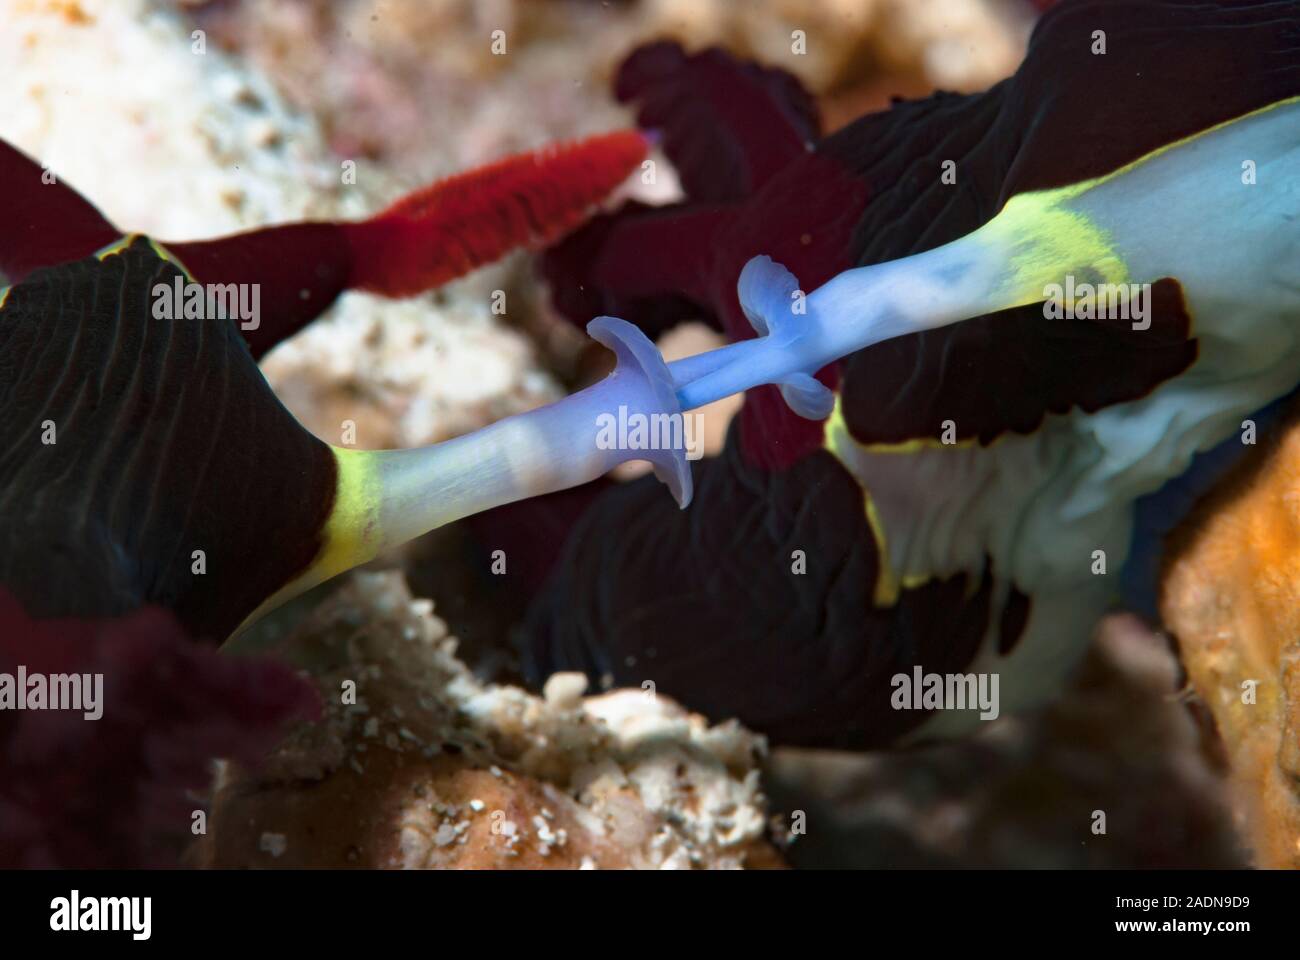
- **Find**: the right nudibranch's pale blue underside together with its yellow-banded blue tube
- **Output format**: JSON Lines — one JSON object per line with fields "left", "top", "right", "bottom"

{"left": 670, "top": 98, "right": 1300, "bottom": 734}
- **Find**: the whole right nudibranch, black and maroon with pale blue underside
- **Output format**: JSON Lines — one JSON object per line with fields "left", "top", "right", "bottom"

{"left": 514, "top": 0, "right": 1300, "bottom": 748}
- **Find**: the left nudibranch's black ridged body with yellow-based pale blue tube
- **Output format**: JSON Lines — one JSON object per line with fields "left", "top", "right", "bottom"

{"left": 0, "top": 227, "right": 690, "bottom": 640}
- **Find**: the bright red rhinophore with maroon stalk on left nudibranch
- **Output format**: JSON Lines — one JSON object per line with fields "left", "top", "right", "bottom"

{"left": 0, "top": 130, "right": 654, "bottom": 356}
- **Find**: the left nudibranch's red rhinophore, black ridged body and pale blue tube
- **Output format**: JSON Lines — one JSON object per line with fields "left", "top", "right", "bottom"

{"left": 0, "top": 131, "right": 660, "bottom": 641}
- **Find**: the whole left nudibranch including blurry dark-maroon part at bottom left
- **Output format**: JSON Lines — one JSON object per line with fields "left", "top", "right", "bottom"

{"left": 0, "top": 125, "right": 690, "bottom": 866}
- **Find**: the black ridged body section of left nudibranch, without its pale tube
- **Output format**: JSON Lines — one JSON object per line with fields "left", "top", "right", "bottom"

{"left": 0, "top": 237, "right": 335, "bottom": 640}
